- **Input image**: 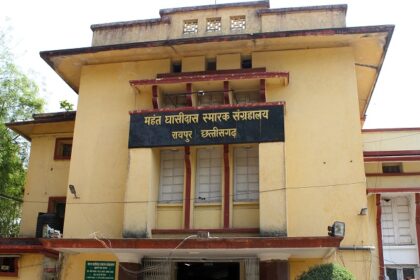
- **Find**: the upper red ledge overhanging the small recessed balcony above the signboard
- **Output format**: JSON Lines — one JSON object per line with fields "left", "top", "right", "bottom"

{"left": 130, "top": 71, "right": 289, "bottom": 86}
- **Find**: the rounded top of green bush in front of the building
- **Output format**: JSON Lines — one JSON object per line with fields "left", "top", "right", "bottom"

{"left": 298, "top": 263, "right": 356, "bottom": 280}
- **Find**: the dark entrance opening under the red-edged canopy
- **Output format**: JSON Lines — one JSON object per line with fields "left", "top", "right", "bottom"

{"left": 176, "top": 262, "right": 239, "bottom": 280}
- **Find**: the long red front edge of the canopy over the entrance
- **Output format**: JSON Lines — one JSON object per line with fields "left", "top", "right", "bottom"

{"left": 42, "top": 236, "right": 343, "bottom": 250}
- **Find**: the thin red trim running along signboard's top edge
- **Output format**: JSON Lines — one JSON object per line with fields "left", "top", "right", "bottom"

{"left": 129, "top": 102, "right": 286, "bottom": 115}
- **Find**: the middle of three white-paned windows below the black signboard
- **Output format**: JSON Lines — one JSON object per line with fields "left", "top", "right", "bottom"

{"left": 195, "top": 147, "right": 222, "bottom": 202}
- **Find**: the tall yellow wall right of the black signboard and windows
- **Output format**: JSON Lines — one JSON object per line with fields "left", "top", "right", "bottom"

{"left": 253, "top": 48, "right": 367, "bottom": 245}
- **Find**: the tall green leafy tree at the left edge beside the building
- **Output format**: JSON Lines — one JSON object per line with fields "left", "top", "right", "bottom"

{"left": 0, "top": 30, "right": 44, "bottom": 237}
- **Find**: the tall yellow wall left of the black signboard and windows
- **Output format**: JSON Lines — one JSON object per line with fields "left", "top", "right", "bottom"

{"left": 64, "top": 59, "right": 170, "bottom": 238}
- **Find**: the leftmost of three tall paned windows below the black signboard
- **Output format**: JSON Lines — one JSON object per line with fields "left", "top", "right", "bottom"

{"left": 159, "top": 149, "right": 184, "bottom": 203}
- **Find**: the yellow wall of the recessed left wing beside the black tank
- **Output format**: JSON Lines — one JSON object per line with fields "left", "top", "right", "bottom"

{"left": 19, "top": 133, "right": 72, "bottom": 237}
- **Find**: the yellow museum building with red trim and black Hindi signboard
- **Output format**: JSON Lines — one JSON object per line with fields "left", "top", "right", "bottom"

{"left": 0, "top": 1, "right": 406, "bottom": 279}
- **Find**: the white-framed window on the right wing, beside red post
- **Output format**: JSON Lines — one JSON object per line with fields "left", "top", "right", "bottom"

{"left": 381, "top": 196, "right": 413, "bottom": 245}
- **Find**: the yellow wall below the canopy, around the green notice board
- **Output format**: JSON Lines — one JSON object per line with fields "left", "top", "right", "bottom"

{"left": 60, "top": 253, "right": 119, "bottom": 280}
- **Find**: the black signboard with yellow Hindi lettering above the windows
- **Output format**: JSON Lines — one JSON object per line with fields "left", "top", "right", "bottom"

{"left": 128, "top": 103, "right": 284, "bottom": 148}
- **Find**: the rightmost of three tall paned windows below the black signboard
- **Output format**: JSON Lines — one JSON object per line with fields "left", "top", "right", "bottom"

{"left": 233, "top": 146, "right": 259, "bottom": 201}
